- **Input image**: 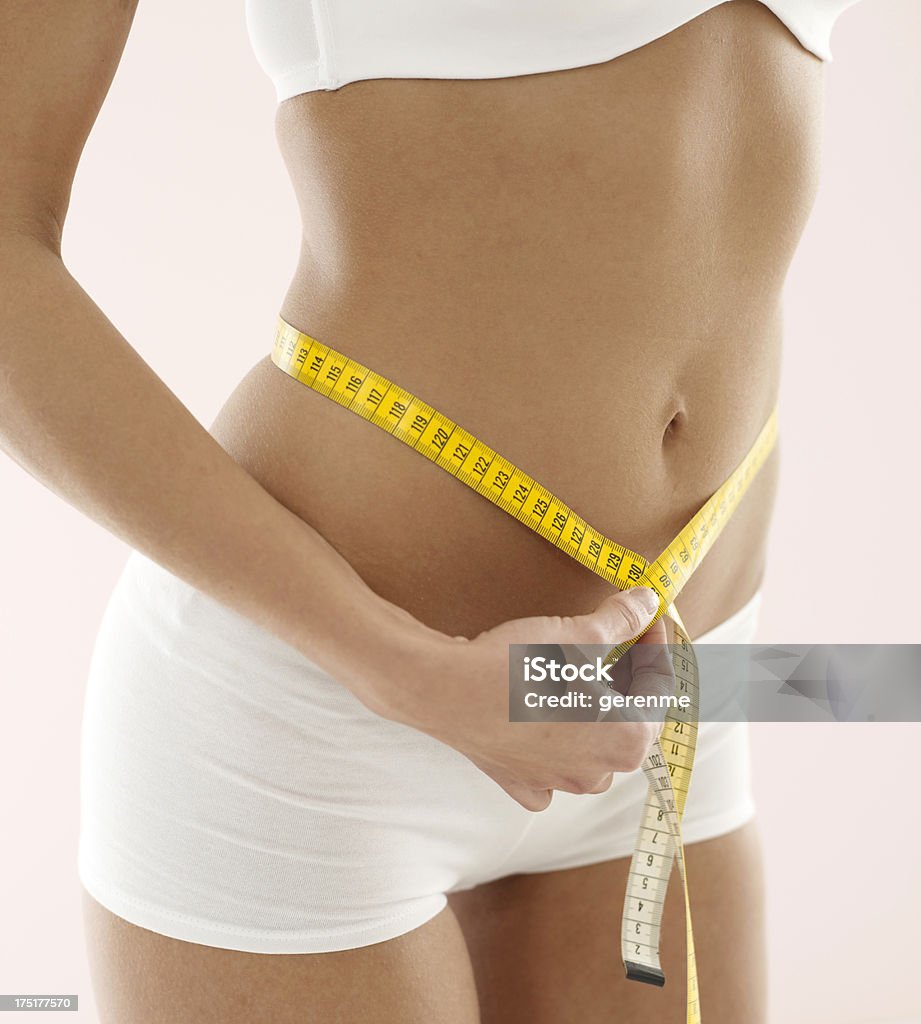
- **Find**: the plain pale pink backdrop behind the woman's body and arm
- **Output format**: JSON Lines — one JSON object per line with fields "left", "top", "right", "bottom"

{"left": 0, "top": 0, "right": 921, "bottom": 1024}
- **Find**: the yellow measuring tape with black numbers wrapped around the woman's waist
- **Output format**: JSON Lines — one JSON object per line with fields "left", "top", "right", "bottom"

{"left": 271, "top": 316, "right": 778, "bottom": 1024}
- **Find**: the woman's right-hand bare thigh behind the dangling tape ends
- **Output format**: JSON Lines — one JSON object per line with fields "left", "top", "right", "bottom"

{"left": 449, "top": 822, "right": 765, "bottom": 1024}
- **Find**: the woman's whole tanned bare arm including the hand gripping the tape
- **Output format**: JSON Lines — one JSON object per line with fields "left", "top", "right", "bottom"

{"left": 0, "top": 0, "right": 671, "bottom": 810}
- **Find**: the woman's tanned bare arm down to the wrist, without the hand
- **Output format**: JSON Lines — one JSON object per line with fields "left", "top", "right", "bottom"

{"left": 0, "top": 0, "right": 425, "bottom": 699}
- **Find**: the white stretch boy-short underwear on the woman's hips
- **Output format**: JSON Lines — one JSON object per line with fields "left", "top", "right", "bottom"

{"left": 78, "top": 551, "right": 761, "bottom": 953}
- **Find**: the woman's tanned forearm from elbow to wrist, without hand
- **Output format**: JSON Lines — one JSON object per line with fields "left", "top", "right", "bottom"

{"left": 0, "top": 237, "right": 430, "bottom": 699}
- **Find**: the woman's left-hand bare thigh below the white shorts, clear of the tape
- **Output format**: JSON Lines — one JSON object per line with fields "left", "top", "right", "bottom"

{"left": 83, "top": 890, "right": 479, "bottom": 1024}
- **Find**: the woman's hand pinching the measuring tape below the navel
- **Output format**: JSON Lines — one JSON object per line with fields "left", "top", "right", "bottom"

{"left": 374, "top": 587, "right": 674, "bottom": 811}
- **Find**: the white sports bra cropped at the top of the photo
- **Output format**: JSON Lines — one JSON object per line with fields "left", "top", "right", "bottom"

{"left": 246, "top": 0, "right": 856, "bottom": 102}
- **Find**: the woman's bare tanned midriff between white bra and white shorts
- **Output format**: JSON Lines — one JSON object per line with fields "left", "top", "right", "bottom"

{"left": 211, "top": 0, "right": 823, "bottom": 636}
